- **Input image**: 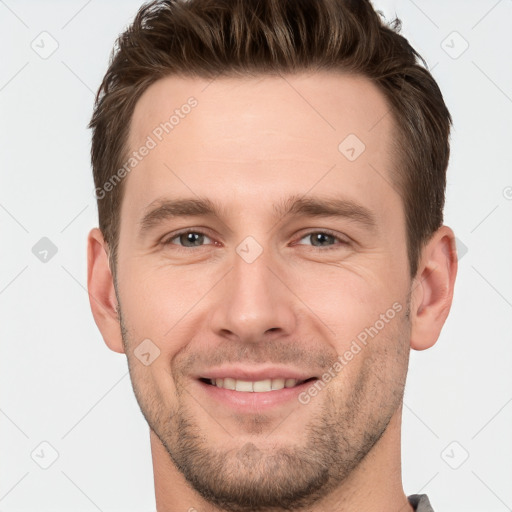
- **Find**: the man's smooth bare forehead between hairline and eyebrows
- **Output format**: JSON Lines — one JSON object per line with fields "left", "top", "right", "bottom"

{"left": 122, "top": 72, "right": 400, "bottom": 220}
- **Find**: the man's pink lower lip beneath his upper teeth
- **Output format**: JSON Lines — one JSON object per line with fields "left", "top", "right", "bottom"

{"left": 197, "top": 379, "right": 317, "bottom": 412}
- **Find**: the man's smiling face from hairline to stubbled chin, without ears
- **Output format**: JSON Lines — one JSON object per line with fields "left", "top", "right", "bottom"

{"left": 117, "top": 73, "right": 411, "bottom": 511}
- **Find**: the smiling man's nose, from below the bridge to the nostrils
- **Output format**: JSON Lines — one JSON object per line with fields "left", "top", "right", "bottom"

{"left": 211, "top": 245, "right": 297, "bottom": 343}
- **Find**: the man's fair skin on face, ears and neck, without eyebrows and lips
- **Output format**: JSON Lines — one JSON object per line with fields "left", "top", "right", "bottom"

{"left": 88, "top": 72, "right": 457, "bottom": 512}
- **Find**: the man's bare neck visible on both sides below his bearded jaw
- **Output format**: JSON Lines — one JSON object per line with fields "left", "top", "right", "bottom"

{"left": 150, "top": 407, "right": 413, "bottom": 512}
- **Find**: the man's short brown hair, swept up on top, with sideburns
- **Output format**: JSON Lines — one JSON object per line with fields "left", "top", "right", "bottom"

{"left": 89, "top": 0, "right": 452, "bottom": 276}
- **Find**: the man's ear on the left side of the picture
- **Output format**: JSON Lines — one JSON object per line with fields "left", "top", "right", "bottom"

{"left": 87, "top": 228, "right": 124, "bottom": 354}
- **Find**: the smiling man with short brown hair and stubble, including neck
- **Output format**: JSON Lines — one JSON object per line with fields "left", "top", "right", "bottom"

{"left": 88, "top": 0, "right": 457, "bottom": 512}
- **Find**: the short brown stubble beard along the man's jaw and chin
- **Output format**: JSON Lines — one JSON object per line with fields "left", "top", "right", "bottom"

{"left": 118, "top": 300, "right": 410, "bottom": 512}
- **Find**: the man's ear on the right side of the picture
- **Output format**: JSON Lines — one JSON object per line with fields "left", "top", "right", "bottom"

{"left": 410, "top": 226, "right": 457, "bottom": 350}
